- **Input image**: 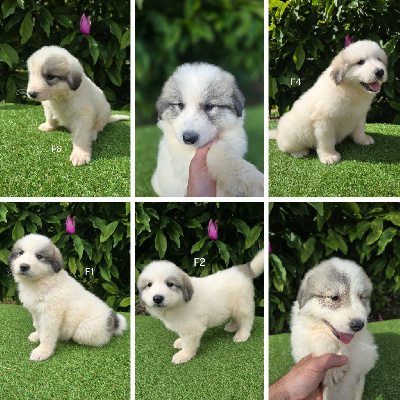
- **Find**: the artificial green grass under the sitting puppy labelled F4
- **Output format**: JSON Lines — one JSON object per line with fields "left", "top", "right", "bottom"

{"left": 268, "top": 121, "right": 400, "bottom": 197}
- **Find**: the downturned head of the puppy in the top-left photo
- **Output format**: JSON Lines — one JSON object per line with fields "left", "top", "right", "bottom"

{"left": 27, "top": 46, "right": 83, "bottom": 101}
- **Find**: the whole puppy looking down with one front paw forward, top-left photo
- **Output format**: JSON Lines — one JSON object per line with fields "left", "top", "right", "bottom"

{"left": 27, "top": 46, "right": 129, "bottom": 166}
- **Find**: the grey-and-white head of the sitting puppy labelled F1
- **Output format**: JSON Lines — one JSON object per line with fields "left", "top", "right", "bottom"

{"left": 8, "top": 234, "right": 63, "bottom": 282}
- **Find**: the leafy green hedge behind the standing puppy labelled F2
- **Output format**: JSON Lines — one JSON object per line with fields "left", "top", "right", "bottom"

{"left": 135, "top": 203, "right": 264, "bottom": 316}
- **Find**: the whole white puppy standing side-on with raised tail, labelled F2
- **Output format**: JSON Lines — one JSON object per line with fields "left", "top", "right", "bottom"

{"left": 137, "top": 250, "right": 264, "bottom": 364}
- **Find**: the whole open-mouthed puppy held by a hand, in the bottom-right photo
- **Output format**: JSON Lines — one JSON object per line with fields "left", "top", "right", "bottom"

{"left": 291, "top": 258, "right": 378, "bottom": 400}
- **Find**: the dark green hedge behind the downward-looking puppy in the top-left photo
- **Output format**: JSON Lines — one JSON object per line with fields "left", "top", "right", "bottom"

{"left": 0, "top": 0, "right": 130, "bottom": 109}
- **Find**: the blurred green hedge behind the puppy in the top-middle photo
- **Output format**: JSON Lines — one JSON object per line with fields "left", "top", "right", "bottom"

{"left": 135, "top": 0, "right": 264, "bottom": 124}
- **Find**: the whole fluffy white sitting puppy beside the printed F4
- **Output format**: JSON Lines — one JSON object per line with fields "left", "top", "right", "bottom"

{"left": 269, "top": 40, "right": 387, "bottom": 164}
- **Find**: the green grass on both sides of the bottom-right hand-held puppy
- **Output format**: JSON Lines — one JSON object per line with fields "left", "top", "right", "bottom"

{"left": 269, "top": 319, "right": 400, "bottom": 400}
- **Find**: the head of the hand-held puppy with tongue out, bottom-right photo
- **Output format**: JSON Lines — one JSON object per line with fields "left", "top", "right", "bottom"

{"left": 297, "top": 258, "right": 372, "bottom": 343}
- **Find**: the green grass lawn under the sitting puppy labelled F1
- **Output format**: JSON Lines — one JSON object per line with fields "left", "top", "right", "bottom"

{"left": 0, "top": 304, "right": 131, "bottom": 400}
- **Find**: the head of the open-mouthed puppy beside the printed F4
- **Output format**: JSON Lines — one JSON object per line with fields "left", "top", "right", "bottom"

{"left": 331, "top": 40, "right": 388, "bottom": 94}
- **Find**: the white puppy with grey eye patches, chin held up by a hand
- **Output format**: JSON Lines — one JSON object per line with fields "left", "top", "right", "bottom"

{"left": 151, "top": 63, "right": 264, "bottom": 197}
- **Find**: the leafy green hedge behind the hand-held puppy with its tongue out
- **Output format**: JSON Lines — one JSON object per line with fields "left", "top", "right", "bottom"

{"left": 269, "top": 203, "right": 400, "bottom": 333}
